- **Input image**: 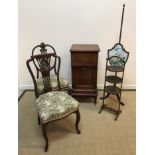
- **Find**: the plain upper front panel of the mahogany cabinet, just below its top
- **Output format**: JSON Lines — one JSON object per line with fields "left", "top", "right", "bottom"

{"left": 71, "top": 52, "right": 98, "bottom": 66}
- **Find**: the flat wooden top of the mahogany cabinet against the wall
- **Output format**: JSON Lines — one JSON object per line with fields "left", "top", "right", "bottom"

{"left": 70, "top": 44, "right": 100, "bottom": 52}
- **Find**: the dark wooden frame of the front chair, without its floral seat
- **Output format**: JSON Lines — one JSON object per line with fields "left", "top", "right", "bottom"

{"left": 26, "top": 53, "right": 81, "bottom": 152}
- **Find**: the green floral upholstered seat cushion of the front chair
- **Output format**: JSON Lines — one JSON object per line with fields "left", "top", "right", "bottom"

{"left": 36, "top": 91, "right": 79, "bottom": 123}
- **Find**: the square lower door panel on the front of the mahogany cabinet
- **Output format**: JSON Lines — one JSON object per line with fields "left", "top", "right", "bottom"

{"left": 72, "top": 66, "right": 96, "bottom": 89}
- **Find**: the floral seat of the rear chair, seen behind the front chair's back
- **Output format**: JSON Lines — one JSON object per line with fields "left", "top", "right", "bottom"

{"left": 36, "top": 75, "right": 69, "bottom": 92}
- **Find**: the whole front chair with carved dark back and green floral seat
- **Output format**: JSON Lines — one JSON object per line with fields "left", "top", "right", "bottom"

{"left": 26, "top": 53, "right": 80, "bottom": 152}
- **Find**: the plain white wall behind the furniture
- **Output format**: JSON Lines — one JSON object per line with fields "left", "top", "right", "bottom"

{"left": 18, "top": 0, "right": 136, "bottom": 89}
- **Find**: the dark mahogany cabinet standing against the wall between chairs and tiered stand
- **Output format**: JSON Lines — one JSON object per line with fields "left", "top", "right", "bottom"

{"left": 70, "top": 44, "right": 100, "bottom": 104}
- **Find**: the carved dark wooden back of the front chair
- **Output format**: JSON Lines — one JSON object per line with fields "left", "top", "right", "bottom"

{"left": 26, "top": 53, "right": 60, "bottom": 98}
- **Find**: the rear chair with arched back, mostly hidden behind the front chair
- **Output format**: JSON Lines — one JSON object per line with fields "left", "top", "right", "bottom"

{"left": 31, "top": 42, "right": 69, "bottom": 92}
